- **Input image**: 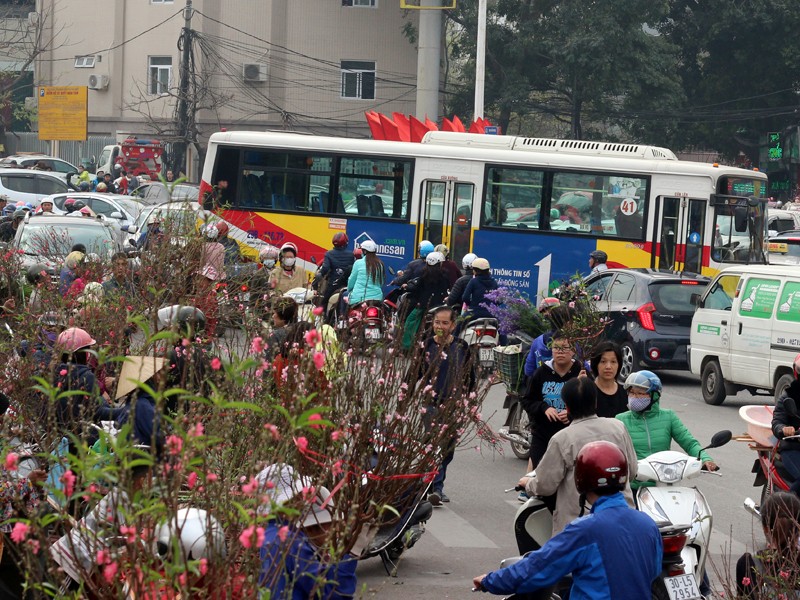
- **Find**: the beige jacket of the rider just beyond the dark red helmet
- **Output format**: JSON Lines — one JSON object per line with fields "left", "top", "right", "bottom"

{"left": 526, "top": 415, "right": 636, "bottom": 535}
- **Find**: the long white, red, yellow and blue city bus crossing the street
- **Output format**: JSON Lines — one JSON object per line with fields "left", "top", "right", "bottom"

{"left": 200, "top": 131, "right": 767, "bottom": 297}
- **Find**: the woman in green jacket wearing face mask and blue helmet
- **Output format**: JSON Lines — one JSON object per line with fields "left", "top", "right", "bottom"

{"left": 617, "top": 371, "right": 719, "bottom": 489}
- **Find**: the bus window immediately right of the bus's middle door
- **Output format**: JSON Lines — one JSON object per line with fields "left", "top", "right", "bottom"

{"left": 483, "top": 167, "right": 544, "bottom": 229}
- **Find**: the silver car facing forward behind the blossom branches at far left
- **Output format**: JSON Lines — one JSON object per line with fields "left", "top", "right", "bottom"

{"left": 13, "top": 214, "right": 123, "bottom": 269}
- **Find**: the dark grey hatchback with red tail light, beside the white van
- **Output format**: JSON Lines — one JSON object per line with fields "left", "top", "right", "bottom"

{"left": 586, "top": 269, "right": 709, "bottom": 379}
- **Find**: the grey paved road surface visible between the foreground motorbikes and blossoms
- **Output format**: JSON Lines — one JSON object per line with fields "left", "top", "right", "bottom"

{"left": 358, "top": 372, "right": 772, "bottom": 600}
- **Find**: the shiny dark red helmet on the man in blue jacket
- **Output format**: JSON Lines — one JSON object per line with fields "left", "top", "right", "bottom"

{"left": 575, "top": 441, "right": 628, "bottom": 495}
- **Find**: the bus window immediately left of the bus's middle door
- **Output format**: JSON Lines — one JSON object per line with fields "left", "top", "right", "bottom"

{"left": 332, "top": 157, "right": 412, "bottom": 219}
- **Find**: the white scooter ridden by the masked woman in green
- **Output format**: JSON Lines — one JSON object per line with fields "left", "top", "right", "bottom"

{"left": 636, "top": 431, "right": 733, "bottom": 599}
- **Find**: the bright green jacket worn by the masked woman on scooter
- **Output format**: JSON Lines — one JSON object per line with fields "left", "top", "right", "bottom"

{"left": 617, "top": 402, "right": 711, "bottom": 489}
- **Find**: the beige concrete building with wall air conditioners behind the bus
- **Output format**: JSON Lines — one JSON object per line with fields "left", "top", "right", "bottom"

{"left": 35, "top": 0, "right": 418, "bottom": 139}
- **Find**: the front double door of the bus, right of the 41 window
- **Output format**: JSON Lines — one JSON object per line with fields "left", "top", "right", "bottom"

{"left": 651, "top": 196, "right": 708, "bottom": 273}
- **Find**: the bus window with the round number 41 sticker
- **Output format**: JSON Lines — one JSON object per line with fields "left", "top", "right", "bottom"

{"left": 550, "top": 172, "right": 648, "bottom": 240}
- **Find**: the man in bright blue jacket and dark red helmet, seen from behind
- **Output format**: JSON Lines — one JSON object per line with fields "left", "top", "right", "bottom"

{"left": 473, "top": 441, "right": 662, "bottom": 600}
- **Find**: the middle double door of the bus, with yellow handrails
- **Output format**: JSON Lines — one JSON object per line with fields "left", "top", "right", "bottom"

{"left": 419, "top": 180, "right": 475, "bottom": 265}
